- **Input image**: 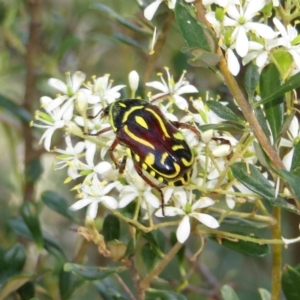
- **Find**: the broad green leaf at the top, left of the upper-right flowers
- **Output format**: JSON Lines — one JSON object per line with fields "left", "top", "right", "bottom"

{"left": 174, "top": 1, "right": 212, "bottom": 52}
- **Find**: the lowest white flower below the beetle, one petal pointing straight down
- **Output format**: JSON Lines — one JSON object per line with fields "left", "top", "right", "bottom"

{"left": 155, "top": 192, "right": 219, "bottom": 243}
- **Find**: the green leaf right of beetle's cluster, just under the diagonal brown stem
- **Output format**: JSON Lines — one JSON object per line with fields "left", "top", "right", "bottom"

{"left": 230, "top": 162, "right": 275, "bottom": 199}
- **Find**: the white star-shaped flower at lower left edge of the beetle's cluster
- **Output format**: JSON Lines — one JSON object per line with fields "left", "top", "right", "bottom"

{"left": 70, "top": 181, "right": 120, "bottom": 219}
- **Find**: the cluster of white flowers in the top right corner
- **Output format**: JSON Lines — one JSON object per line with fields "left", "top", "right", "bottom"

{"left": 144, "top": 0, "right": 300, "bottom": 76}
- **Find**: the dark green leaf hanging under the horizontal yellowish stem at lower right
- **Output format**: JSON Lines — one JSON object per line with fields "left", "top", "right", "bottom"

{"left": 210, "top": 232, "right": 270, "bottom": 257}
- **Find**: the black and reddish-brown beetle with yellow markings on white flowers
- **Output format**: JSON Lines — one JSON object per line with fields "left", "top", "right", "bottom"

{"left": 92, "top": 99, "right": 199, "bottom": 213}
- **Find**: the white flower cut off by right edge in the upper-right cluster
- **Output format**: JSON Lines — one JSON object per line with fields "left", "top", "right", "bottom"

{"left": 273, "top": 18, "right": 300, "bottom": 69}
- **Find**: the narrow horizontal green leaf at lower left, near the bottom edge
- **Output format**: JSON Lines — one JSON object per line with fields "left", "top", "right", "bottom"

{"left": 64, "top": 263, "right": 118, "bottom": 280}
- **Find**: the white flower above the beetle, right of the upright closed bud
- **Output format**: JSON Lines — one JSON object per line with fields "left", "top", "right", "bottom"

{"left": 146, "top": 67, "right": 198, "bottom": 110}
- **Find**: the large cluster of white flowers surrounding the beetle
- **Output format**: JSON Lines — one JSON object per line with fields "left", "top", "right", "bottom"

{"left": 32, "top": 68, "right": 262, "bottom": 243}
